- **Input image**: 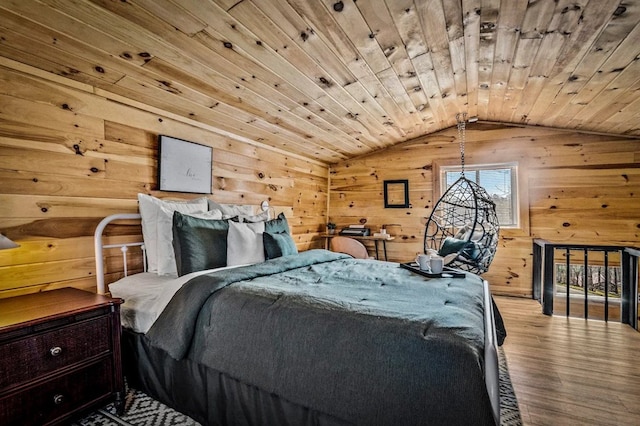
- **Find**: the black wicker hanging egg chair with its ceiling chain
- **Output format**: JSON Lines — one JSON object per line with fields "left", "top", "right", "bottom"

{"left": 424, "top": 114, "right": 500, "bottom": 275}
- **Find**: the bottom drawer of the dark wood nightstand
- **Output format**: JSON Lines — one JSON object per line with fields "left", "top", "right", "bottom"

{"left": 0, "top": 358, "right": 113, "bottom": 426}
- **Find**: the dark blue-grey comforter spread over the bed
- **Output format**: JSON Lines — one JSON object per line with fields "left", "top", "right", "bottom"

{"left": 147, "top": 250, "right": 495, "bottom": 425}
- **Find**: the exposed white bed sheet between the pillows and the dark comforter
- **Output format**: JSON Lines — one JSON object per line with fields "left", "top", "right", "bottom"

{"left": 109, "top": 265, "right": 243, "bottom": 333}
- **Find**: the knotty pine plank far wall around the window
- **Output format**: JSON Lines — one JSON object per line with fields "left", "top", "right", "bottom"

{"left": 329, "top": 123, "right": 640, "bottom": 296}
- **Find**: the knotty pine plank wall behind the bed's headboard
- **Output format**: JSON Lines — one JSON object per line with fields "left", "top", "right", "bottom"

{"left": 0, "top": 58, "right": 328, "bottom": 297}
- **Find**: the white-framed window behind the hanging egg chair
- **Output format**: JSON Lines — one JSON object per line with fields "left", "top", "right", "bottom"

{"left": 440, "top": 163, "right": 519, "bottom": 228}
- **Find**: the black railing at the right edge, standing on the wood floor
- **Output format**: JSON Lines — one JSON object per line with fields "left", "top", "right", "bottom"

{"left": 533, "top": 239, "right": 640, "bottom": 330}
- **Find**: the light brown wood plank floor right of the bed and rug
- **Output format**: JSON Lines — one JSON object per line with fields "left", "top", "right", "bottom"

{"left": 495, "top": 296, "right": 640, "bottom": 426}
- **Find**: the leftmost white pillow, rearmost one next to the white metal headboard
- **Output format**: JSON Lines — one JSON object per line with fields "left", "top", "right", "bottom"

{"left": 138, "top": 194, "right": 207, "bottom": 273}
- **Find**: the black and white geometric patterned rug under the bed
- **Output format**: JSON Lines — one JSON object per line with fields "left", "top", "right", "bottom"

{"left": 72, "top": 348, "right": 522, "bottom": 426}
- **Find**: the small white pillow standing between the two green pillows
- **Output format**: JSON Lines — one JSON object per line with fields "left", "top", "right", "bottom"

{"left": 227, "top": 221, "right": 264, "bottom": 266}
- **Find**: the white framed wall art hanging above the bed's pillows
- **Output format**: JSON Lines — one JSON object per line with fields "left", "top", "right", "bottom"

{"left": 158, "top": 135, "right": 213, "bottom": 194}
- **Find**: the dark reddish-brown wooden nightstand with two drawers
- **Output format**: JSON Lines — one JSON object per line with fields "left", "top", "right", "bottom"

{"left": 0, "top": 288, "right": 125, "bottom": 425}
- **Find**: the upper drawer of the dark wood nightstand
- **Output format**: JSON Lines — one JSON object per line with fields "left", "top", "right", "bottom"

{"left": 0, "top": 316, "right": 111, "bottom": 389}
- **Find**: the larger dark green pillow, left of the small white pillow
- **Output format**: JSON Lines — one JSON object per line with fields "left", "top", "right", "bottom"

{"left": 173, "top": 212, "right": 229, "bottom": 276}
